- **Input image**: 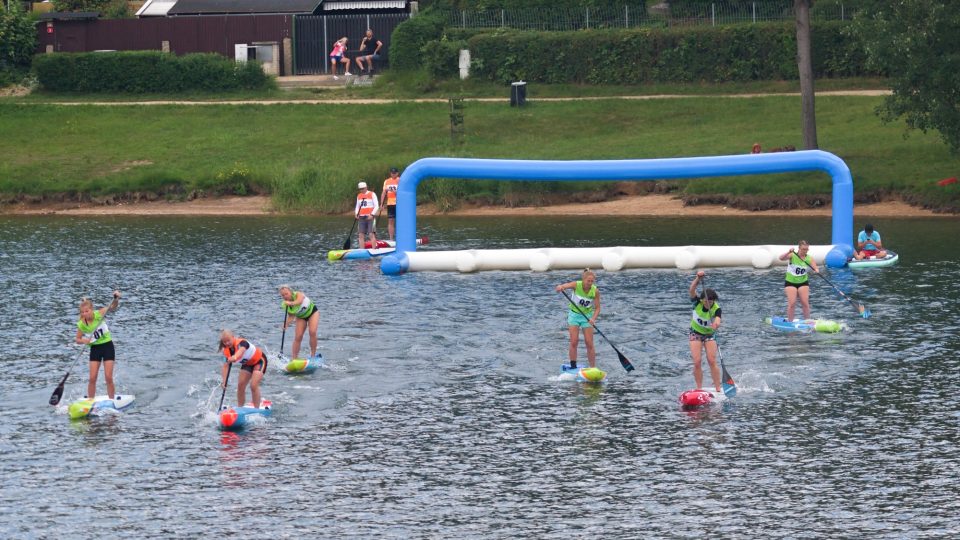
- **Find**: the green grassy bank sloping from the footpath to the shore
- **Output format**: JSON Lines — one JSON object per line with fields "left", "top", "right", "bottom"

{"left": 0, "top": 96, "right": 960, "bottom": 212}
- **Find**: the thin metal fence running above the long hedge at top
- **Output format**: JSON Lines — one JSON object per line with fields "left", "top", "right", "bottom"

{"left": 448, "top": 0, "right": 853, "bottom": 31}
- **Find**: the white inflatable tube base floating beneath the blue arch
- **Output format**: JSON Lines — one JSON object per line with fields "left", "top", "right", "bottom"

{"left": 406, "top": 245, "right": 835, "bottom": 273}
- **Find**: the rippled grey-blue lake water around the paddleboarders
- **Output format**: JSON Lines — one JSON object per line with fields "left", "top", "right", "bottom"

{"left": 0, "top": 217, "right": 960, "bottom": 538}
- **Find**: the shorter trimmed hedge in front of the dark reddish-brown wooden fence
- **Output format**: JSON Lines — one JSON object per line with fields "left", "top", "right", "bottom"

{"left": 33, "top": 51, "right": 275, "bottom": 94}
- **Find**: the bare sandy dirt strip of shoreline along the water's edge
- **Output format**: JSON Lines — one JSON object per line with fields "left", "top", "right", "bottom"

{"left": 0, "top": 194, "right": 960, "bottom": 218}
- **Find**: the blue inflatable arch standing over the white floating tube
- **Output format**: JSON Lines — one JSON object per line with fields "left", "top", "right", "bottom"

{"left": 380, "top": 150, "right": 853, "bottom": 274}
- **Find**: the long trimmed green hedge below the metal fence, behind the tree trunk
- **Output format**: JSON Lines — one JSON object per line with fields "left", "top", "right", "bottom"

{"left": 424, "top": 22, "right": 877, "bottom": 84}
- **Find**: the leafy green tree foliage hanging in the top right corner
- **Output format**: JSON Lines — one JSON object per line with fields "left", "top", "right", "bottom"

{"left": 852, "top": 0, "right": 960, "bottom": 152}
